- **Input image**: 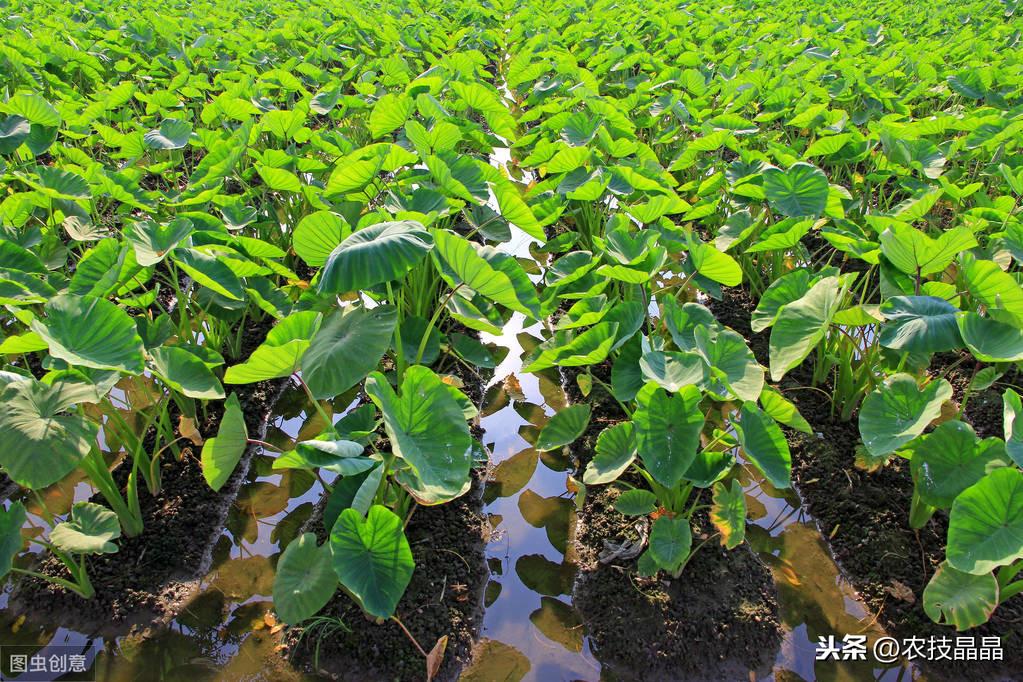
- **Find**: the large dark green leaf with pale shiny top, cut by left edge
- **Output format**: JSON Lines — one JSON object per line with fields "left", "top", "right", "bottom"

{"left": 0, "top": 380, "right": 98, "bottom": 490}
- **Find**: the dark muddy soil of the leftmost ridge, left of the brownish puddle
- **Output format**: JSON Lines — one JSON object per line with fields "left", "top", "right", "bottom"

{"left": 10, "top": 323, "right": 287, "bottom": 634}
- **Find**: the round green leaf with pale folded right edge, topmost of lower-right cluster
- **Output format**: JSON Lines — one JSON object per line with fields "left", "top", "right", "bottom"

{"left": 859, "top": 373, "right": 952, "bottom": 457}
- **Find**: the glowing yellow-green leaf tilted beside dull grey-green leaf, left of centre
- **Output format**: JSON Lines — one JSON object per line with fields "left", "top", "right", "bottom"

{"left": 224, "top": 311, "right": 320, "bottom": 383}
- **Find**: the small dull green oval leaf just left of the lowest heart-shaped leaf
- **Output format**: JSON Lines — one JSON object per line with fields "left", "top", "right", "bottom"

{"left": 273, "top": 533, "right": 338, "bottom": 625}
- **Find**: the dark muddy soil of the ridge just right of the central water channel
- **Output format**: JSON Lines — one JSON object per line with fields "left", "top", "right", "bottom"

{"left": 565, "top": 365, "right": 782, "bottom": 680}
